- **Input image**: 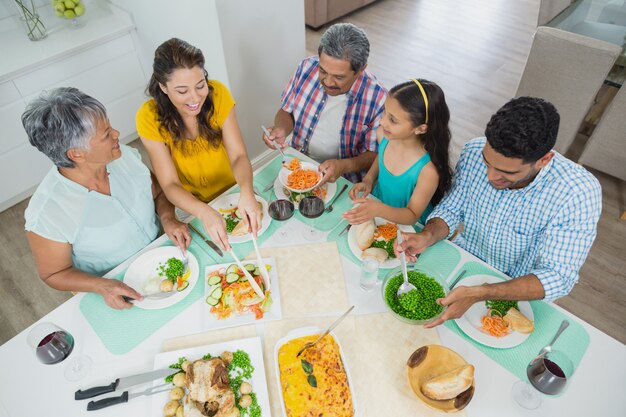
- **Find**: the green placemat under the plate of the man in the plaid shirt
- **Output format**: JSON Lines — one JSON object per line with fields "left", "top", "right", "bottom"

{"left": 251, "top": 156, "right": 353, "bottom": 232}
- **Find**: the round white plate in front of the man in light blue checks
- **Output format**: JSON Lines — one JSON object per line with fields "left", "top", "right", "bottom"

{"left": 455, "top": 275, "right": 535, "bottom": 349}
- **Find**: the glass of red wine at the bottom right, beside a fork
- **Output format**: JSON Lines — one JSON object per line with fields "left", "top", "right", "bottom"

{"left": 512, "top": 350, "right": 574, "bottom": 410}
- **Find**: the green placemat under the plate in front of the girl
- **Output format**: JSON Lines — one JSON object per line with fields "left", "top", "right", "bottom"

{"left": 328, "top": 222, "right": 461, "bottom": 280}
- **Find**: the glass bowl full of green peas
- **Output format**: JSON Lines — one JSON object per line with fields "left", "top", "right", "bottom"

{"left": 381, "top": 265, "right": 448, "bottom": 324}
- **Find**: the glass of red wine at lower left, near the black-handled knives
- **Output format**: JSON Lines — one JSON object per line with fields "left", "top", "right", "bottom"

{"left": 26, "top": 322, "right": 91, "bottom": 381}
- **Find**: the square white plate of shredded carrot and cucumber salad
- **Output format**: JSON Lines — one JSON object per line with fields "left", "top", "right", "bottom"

{"left": 202, "top": 258, "right": 282, "bottom": 329}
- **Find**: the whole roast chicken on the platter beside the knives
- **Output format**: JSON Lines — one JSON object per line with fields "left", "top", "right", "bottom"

{"left": 184, "top": 358, "right": 239, "bottom": 417}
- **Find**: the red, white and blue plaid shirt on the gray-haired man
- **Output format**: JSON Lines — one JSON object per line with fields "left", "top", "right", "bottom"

{"left": 281, "top": 56, "right": 387, "bottom": 182}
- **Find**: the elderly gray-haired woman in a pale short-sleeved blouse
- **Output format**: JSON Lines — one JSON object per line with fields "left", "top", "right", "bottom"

{"left": 22, "top": 88, "right": 191, "bottom": 309}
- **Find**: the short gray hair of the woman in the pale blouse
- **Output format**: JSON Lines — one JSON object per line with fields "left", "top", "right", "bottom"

{"left": 22, "top": 87, "right": 107, "bottom": 168}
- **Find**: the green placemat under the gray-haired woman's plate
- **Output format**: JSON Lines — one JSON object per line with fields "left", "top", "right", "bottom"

{"left": 80, "top": 241, "right": 215, "bottom": 355}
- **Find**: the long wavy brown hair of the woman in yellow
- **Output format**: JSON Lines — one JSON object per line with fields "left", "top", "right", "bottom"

{"left": 147, "top": 38, "right": 222, "bottom": 149}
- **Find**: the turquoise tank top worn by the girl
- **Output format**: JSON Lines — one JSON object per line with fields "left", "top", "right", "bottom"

{"left": 372, "top": 138, "right": 433, "bottom": 224}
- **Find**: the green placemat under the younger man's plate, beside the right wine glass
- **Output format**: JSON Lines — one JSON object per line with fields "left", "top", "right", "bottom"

{"left": 445, "top": 262, "right": 589, "bottom": 381}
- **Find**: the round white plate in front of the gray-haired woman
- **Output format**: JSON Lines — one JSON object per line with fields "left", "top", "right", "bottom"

{"left": 124, "top": 246, "right": 200, "bottom": 310}
